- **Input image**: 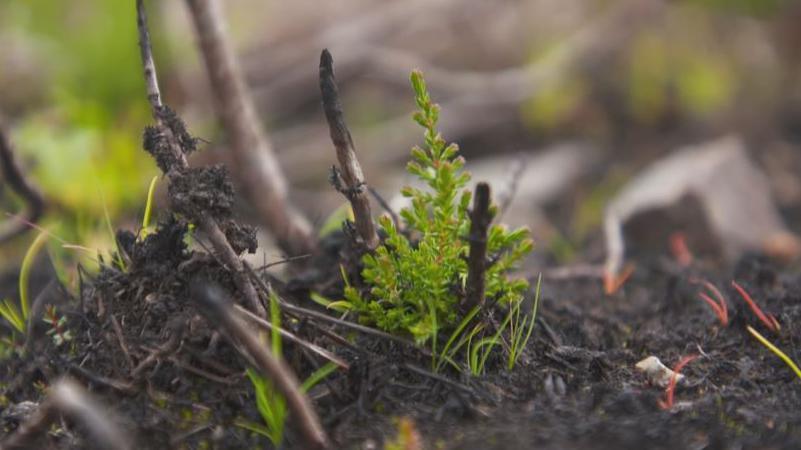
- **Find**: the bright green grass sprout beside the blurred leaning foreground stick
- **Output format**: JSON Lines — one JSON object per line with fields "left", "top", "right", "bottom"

{"left": 236, "top": 292, "right": 337, "bottom": 448}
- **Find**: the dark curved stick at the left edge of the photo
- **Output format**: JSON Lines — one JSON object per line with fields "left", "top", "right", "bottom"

{"left": 0, "top": 123, "right": 45, "bottom": 243}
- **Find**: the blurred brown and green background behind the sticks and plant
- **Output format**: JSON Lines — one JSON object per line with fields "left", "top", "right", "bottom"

{"left": 0, "top": 0, "right": 801, "bottom": 280}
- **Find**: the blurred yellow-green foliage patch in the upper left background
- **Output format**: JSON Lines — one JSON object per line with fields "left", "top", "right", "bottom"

{"left": 0, "top": 0, "right": 161, "bottom": 220}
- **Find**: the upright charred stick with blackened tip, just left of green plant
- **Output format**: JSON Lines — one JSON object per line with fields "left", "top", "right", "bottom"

{"left": 320, "top": 49, "right": 379, "bottom": 250}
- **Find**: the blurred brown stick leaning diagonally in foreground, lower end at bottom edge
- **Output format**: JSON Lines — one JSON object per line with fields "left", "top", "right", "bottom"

{"left": 193, "top": 282, "right": 330, "bottom": 449}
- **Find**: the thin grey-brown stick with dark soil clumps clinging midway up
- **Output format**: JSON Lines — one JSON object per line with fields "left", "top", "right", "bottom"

{"left": 136, "top": 0, "right": 267, "bottom": 317}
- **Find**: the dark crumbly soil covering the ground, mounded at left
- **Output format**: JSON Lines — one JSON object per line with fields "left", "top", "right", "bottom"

{"left": 0, "top": 75, "right": 801, "bottom": 449}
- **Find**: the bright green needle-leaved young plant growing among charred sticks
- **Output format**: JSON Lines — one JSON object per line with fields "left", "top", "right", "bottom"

{"left": 345, "top": 71, "right": 533, "bottom": 368}
